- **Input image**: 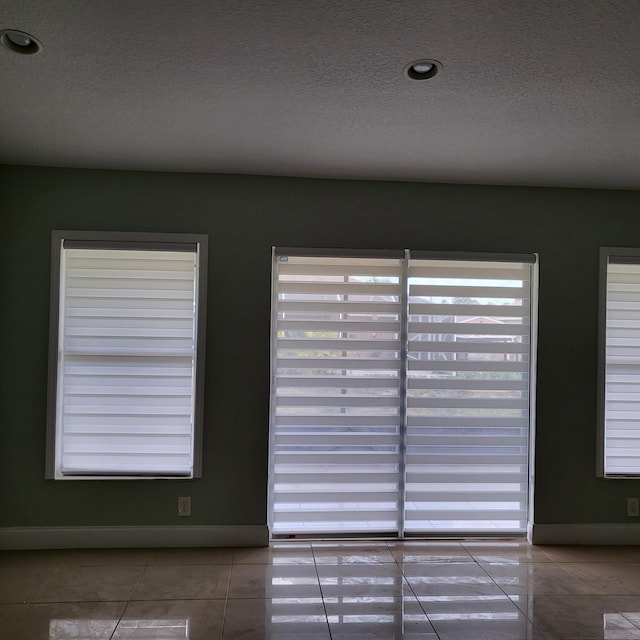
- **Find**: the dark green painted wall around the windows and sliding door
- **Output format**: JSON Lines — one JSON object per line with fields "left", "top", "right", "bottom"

{"left": 0, "top": 166, "right": 640, "bottom": 527}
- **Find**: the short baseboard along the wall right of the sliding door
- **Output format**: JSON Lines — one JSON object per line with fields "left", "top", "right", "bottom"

{"left": 528, "top": 523, "right": 640, "bottom": 545}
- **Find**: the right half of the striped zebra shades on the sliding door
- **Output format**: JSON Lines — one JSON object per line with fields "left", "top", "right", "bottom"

{"left": 405, "top": 260, "right": 532, "bottom": 532}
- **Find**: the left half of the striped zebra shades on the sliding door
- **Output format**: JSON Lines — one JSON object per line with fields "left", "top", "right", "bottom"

{"left": 272, "top": 255, "right": 401, "bottom": 534}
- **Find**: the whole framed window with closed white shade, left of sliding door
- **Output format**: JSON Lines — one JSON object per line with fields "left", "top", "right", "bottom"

{"left": 46, "top": 231, "right": 207, "bottom": 479}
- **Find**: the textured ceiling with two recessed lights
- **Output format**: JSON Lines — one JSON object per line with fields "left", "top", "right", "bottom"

{"left": 0, "top": 0, "right": 640, "bottom": 189}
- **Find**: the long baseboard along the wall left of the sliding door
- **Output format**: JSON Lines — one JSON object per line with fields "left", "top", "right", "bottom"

{"left": 0, "top": 525, "right": 269, "bottom": 549}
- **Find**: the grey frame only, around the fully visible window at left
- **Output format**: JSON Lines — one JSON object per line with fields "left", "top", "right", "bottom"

{"left": 45, "top": 230, "right": 208, "bottom": 480}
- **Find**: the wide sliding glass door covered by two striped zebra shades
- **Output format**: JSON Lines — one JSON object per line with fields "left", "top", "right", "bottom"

{"left": 270, "top": 249, "right": 533, "bottom": 536}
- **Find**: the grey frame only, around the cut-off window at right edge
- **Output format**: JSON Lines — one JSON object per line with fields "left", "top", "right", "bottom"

{"left": 596, "top": 247, "right": 640, "bottom": 480}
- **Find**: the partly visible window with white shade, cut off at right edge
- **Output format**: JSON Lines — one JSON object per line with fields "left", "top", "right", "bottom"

{"left": 597, "top": 248, "right": 640, "bottom": 478}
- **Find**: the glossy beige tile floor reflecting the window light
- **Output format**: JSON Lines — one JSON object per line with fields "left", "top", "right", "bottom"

{"left": 0, "top": 539, "right": 640, "bottom": 640}
